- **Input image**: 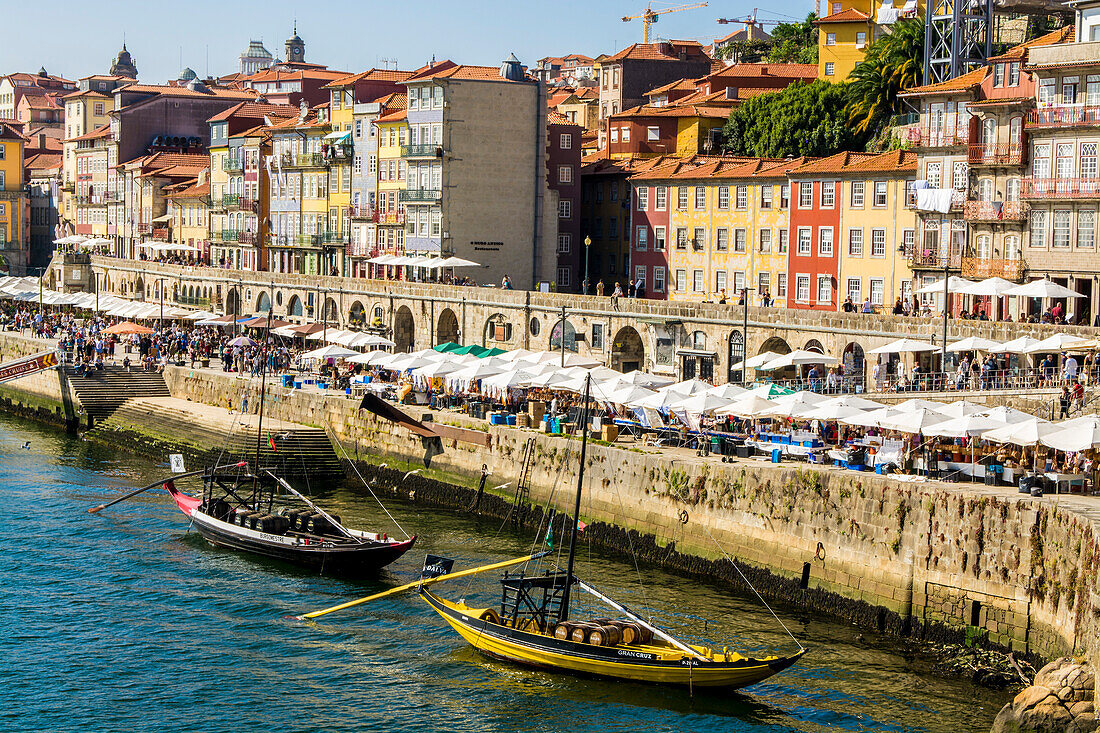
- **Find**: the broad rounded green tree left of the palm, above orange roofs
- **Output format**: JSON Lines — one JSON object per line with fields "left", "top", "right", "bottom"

{"left": 723, "top": 79, "right": 866, "bottom": 157}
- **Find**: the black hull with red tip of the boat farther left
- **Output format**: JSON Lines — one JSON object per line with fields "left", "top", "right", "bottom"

{"left": 168, "top": 488, "right": 416, "bottom": 576}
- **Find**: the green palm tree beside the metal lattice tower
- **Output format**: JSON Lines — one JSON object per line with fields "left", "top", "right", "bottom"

{"left": 848, "top": 19, "right": 924, "bottom": 136}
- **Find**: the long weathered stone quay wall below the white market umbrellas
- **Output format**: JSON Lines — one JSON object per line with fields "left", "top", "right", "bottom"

{"left": 160, "top": 368, "right": 1100, "bottom": 663}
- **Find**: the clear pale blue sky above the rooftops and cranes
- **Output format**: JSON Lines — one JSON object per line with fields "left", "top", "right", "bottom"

{"left": 0, "top": 0, "right": 813, "bottom": 83}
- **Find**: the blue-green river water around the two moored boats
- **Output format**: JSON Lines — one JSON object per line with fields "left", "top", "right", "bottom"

{"left": 0, "top": 417, "right": 1009, "bottom": 733}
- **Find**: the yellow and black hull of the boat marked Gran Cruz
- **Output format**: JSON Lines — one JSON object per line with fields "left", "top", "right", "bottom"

{"left": 420, "top": 588, "right": 805, "bottom": 689}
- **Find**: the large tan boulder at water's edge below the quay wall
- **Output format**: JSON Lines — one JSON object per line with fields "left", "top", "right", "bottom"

{"left": 991, "top": 657, "right": 1098, "bottom": 733}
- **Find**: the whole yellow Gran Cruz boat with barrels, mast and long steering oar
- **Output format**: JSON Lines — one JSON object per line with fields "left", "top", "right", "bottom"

{"left": 301, "top": 378, "right": 806, "bottom": 689}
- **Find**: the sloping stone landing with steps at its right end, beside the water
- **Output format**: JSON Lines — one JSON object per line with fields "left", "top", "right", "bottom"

{"left": 92, "top": 396, "right": 344, "bottom": 481}
